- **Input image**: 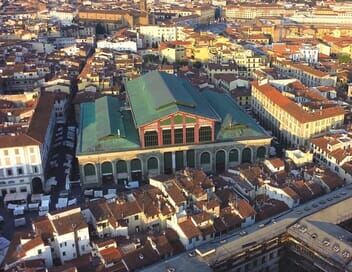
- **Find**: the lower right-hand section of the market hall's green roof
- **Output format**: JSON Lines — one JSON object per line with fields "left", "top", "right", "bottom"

{"left": 201, "top": 89, "right": 268, "bottom": 141}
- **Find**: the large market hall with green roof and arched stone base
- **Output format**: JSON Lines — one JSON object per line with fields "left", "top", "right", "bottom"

{"left": 77, "top": 72, "right": 271, "bottom": 186}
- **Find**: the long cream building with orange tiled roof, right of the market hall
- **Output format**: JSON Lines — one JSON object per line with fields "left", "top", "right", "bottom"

{"left": 252, "top": 82, "right": 344, "bottom": 147}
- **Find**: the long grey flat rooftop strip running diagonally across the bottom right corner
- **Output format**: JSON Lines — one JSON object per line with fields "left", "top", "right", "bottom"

{"left": 142, "top": 184, "right": 352, "bottom": 272}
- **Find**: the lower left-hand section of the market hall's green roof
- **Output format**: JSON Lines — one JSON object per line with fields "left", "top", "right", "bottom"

{"left": 77, "top": 96, "right": 140, "bottom": 154}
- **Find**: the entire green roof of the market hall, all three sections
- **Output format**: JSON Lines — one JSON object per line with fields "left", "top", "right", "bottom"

{"left": 77, "top": 72, "right": 269, "bottom": 155}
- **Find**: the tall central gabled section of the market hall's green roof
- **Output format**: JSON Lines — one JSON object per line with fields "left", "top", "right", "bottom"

{"left": 126, "top": 71, "right": 219, "bottom": 127}
